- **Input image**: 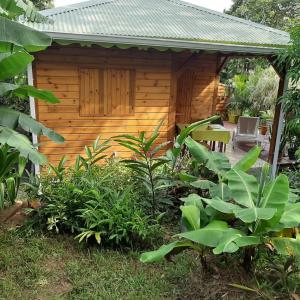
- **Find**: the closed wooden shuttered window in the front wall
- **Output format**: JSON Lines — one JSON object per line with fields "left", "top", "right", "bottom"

{"left": 80, "top": 68, "right": 135, "bottom": 117}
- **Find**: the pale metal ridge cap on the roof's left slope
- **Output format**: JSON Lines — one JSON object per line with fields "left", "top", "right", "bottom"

{"left": 40, "top": 0, "right": 118, "bottom": 16}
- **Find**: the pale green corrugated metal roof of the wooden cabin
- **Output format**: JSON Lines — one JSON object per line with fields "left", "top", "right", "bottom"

{"left": 26, "top": 0, "right": 289, "bottom": 46}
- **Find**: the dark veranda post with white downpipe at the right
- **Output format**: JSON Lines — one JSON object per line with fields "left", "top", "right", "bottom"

{"left": 269, "top": 74, "right": 289, "bottom": 178}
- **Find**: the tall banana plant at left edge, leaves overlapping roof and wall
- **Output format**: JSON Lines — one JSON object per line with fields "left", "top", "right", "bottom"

{"left": 0, "top": 0, "right": 63, "bottom": 164}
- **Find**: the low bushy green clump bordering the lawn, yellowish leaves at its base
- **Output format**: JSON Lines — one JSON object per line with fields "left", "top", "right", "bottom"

{"left": 76, "top": 186, "right": 161, "bottom": 247}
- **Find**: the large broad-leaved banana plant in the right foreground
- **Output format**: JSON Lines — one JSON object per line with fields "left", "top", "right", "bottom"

{"left": 141, "top": 138, "right": 300, "bottom": 267}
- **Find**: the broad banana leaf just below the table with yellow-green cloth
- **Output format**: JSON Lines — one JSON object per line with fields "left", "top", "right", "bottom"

{"left": 185, "top": 137, "right": 230, "bottom": 174}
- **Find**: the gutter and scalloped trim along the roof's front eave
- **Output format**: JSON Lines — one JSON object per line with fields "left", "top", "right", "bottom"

{"left": 44, "top": 31, "right": 284, "bottom": 56}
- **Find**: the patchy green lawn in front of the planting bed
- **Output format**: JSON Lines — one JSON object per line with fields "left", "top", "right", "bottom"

{"left": 0, "top": 229, "right": 251, "bottom": 300}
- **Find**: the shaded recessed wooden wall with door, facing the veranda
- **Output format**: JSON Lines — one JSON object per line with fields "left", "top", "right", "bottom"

{"left": 177, "top": 53, "right": 219, "bottom": 122}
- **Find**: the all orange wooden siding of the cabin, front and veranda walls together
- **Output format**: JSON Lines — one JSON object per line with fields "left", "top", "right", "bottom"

{"left": 34, "top": 45, "right": 218, "bottom": 163}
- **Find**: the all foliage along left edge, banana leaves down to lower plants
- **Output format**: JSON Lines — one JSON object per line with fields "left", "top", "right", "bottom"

{"left": 0, "top": 0, "right": 64, "bottom": 208}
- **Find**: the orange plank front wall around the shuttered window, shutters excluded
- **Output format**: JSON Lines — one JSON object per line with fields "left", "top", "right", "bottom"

{"left": 34, "top": 45, "right": 174, "bottom": 163}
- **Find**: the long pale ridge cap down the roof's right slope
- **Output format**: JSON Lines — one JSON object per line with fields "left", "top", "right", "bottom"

{"left": 169, "top": 0, "right": 289, "bottom": 36}
